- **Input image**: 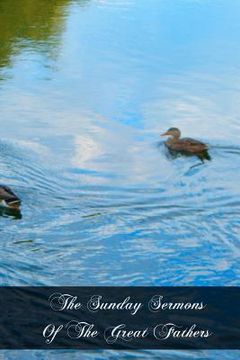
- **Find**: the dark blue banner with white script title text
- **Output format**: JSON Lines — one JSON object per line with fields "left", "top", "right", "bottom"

{"left": 0, "top": 287, "right": 240, "bottom": 349}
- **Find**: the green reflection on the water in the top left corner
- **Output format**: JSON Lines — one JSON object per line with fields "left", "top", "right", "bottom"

{"left": 0, "top": 0, "right": 89, "bottom": 73}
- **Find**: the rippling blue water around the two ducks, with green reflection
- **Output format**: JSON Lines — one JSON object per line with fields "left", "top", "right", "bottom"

{"left": 0, "top": 0, "right": 240, "bottom": 359}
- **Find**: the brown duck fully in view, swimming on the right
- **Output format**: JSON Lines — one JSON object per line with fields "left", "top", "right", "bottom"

{"left": 161, "top": 127, "right": 208, "bottom": 155}
